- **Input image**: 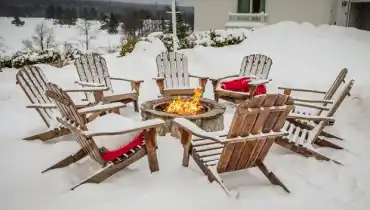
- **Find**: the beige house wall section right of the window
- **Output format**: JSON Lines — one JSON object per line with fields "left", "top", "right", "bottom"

{"left": 266, "top": 0, "right": 333, "bottom": 25}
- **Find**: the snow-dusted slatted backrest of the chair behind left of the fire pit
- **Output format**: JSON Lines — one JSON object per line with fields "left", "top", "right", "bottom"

{"left": 74, "top": 53, "right": 113, "bottom": 94}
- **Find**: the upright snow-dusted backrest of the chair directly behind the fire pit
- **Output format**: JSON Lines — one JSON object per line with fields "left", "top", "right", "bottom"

{"left": 156, "top": 52, "right": 190, "bottom": 89}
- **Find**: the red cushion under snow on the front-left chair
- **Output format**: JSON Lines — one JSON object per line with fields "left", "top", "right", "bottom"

{"left": 102, "top": 131, "right": 144, "bottom": 161}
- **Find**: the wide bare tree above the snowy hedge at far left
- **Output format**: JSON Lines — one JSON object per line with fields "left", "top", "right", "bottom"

{"left": 22, "top": 22, "right": 55, "bottom": 52}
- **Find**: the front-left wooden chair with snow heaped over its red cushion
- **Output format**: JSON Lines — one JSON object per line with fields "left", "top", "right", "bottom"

{"left": 43, "top": 83, "right": 164, "bottom": 190}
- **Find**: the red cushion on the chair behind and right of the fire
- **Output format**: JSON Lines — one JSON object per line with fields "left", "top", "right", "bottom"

{"left": 221, "top": 77, "right": 267, "bottom": 96}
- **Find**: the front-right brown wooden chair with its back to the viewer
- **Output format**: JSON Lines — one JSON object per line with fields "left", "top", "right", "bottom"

{"left": 174, "top": 94, "right": 294, "bottom": 196}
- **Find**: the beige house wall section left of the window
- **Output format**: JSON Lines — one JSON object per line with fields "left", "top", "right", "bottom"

{"left": 194, "top": 0, "right": 237, "bottom": 30}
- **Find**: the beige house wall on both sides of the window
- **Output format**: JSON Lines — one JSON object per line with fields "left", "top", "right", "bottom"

{"left": 194, "top": 0, "right": 340, "bottom": 30}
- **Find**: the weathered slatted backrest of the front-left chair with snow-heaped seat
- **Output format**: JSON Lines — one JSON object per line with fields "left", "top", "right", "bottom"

{"left": 46, "top": 83, "right": 104, "bottom": 164}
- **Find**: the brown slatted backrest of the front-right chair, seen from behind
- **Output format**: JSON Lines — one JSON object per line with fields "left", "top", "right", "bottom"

{"left": 217, "top": 94, "right": 294, "bottom": 173}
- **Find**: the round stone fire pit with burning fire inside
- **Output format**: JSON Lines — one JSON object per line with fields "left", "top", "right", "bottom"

{"left": 140, "top": 89, "right": 226, "bottom": 137}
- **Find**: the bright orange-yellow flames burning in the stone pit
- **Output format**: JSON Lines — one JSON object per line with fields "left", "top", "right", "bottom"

{"left": 165, "top": 88, "right": 203, "bottom": 115}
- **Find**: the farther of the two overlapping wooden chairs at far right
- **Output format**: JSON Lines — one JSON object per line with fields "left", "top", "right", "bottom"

{"left": 279, "top": 68, "right": 350, "bottom": 140}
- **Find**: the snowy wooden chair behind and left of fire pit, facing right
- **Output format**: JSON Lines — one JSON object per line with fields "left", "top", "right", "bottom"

{"left": 74, "top": 54, "right": 144, "bottom": 112}
